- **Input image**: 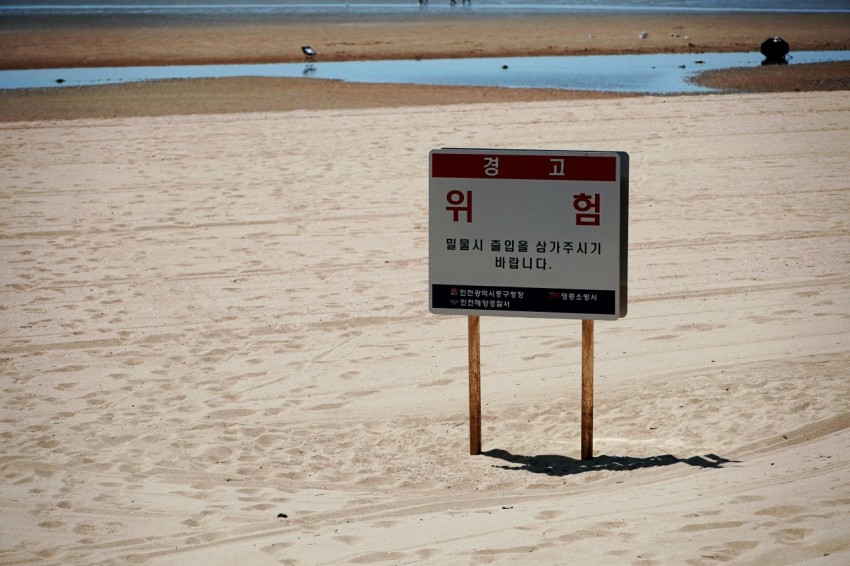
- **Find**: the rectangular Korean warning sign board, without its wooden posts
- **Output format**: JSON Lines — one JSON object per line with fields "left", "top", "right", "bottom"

{"left": 429, "top": 149, "right": 629, "bottom": 320}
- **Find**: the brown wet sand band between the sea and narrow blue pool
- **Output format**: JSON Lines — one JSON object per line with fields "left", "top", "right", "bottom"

{"left": 0, "top": 11, "right": 850, "bottom": 69}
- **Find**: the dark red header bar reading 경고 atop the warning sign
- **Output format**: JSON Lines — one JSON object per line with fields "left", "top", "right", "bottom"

{"left": 431, "top": 153, "right": 617, "bottom": 182}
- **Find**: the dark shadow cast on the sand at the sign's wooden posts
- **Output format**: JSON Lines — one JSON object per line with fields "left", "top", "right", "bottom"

{"left": 481, "top": 448, "right": 737, "bottom": 476}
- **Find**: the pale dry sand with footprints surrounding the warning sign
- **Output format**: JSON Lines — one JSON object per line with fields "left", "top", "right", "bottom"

{"left": 0, "top": 10, "right": 850, "bottom": 565}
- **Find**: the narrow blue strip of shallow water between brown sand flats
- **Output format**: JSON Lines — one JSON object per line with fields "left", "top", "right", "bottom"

{"left": 0, "top": 51, "right": 850, "bottom": 94}
